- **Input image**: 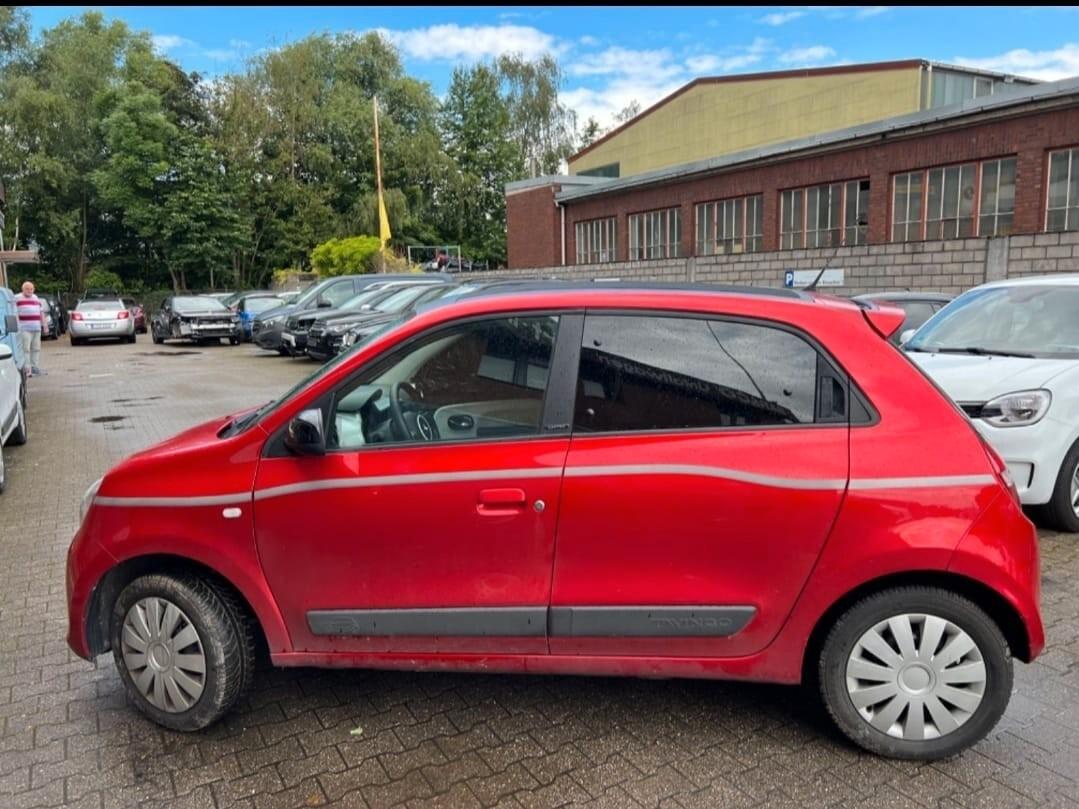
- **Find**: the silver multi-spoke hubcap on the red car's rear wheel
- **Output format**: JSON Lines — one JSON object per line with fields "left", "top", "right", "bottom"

{"left": 847, "top": 614, "right": 985, "bottom": 741}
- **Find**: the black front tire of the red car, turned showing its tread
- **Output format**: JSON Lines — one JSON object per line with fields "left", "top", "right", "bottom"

{"left": 110, "top": 574, "right": 256, "bottom": 732}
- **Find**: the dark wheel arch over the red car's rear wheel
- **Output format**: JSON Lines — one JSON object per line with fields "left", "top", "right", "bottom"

{"left": 802, "top": 570, "right": 1030, "bottom": 684}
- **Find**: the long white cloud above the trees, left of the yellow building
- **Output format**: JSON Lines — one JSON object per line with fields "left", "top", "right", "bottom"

{"left": 378, "top": 23, "right": 565, "bottom": 63}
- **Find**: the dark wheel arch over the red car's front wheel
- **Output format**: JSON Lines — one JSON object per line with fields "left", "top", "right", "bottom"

{"left": 84, "top": 553, "right": 291, "bottom": 658}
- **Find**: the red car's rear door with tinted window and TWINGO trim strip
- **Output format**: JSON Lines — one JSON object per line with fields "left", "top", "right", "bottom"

{"left": 549, "top": 313, "right": 848, "bottom": 657}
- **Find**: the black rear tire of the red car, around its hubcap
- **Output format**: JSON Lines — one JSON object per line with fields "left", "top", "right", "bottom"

{"left": 818, "top": 587, "right": 1012, "bottom": 760}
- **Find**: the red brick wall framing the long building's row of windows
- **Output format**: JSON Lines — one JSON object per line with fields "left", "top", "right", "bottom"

{"left": 506, "top": 108, "right": 1079, "bottom": 268}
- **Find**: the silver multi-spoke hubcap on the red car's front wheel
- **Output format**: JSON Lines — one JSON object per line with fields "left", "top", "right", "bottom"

{"left": 121, "top": 598, "right": 206, "bottom": 713}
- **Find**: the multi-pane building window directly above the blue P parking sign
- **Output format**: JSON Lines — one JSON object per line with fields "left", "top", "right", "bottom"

{"left": 779, "top": 180, "right": 870, "bottom": 250}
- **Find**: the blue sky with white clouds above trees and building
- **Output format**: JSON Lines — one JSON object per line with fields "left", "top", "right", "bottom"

{"left": 23, "top": 5, "right": 1079, "bottom": 126}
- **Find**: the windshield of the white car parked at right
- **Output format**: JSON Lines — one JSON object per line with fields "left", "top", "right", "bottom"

{"left": 904, "top": 285, "right": 1079, "bottom": 358}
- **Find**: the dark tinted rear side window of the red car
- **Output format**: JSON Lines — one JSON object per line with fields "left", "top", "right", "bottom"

{"left": 573, "top": 315, "right": 820, "bottom": 433}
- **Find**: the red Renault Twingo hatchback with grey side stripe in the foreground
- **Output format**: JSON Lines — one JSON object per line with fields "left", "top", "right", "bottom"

{"left": 67, "top": 284, "right": 1044, "bottom": 758}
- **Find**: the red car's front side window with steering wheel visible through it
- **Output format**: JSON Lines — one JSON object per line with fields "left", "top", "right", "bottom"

{"left": 327, "top": 316, "right": 559, "bottom": 450}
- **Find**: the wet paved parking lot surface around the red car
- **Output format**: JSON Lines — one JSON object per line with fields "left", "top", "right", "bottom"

{"left": 0, "top": 337, "right": 1079, "bottom": 809}
